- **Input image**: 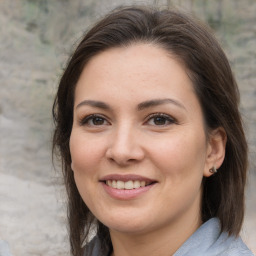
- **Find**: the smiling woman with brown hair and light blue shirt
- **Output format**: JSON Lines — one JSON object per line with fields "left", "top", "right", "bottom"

{"left": 53, "top": 6, "right": 252, "bottom": 256}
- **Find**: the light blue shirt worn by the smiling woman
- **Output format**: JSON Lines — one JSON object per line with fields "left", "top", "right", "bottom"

{"left": 84, "top": 218, "right": 254, "bottom": 256}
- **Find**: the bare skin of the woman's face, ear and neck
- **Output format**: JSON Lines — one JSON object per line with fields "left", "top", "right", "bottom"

{"left": 70, "top": 44, "right": 225, "bottom": 256}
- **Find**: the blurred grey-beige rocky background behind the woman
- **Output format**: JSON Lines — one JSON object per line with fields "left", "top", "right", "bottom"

{"left": 0, "top": 0, "right": 256, "bottom": 256}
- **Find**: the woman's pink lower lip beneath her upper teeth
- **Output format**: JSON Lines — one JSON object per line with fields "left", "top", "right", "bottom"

{"left": 102, "top": 182, "right": 156, "bottom": 200}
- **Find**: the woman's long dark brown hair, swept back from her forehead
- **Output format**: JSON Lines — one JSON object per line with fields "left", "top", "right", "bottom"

{"left": 53, "top": 6, "right": 247, "bottom": 256}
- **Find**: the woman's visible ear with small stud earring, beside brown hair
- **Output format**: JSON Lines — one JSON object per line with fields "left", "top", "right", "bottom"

{"left": 204, "top": 127, "right": 227, "bottom": 177}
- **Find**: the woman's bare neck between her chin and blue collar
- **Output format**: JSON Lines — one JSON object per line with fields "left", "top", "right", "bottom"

{"left": 110, "top": 212, "right": 202, "bottom": 256}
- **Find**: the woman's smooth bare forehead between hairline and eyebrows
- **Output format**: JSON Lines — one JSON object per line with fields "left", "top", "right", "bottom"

{"left": 76, "top": 44, "right": 193, "bottom": 96}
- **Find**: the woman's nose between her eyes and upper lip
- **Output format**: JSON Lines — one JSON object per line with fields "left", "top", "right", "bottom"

{"left": 106, "top": 125, "right": 145, "bottom": 166}
